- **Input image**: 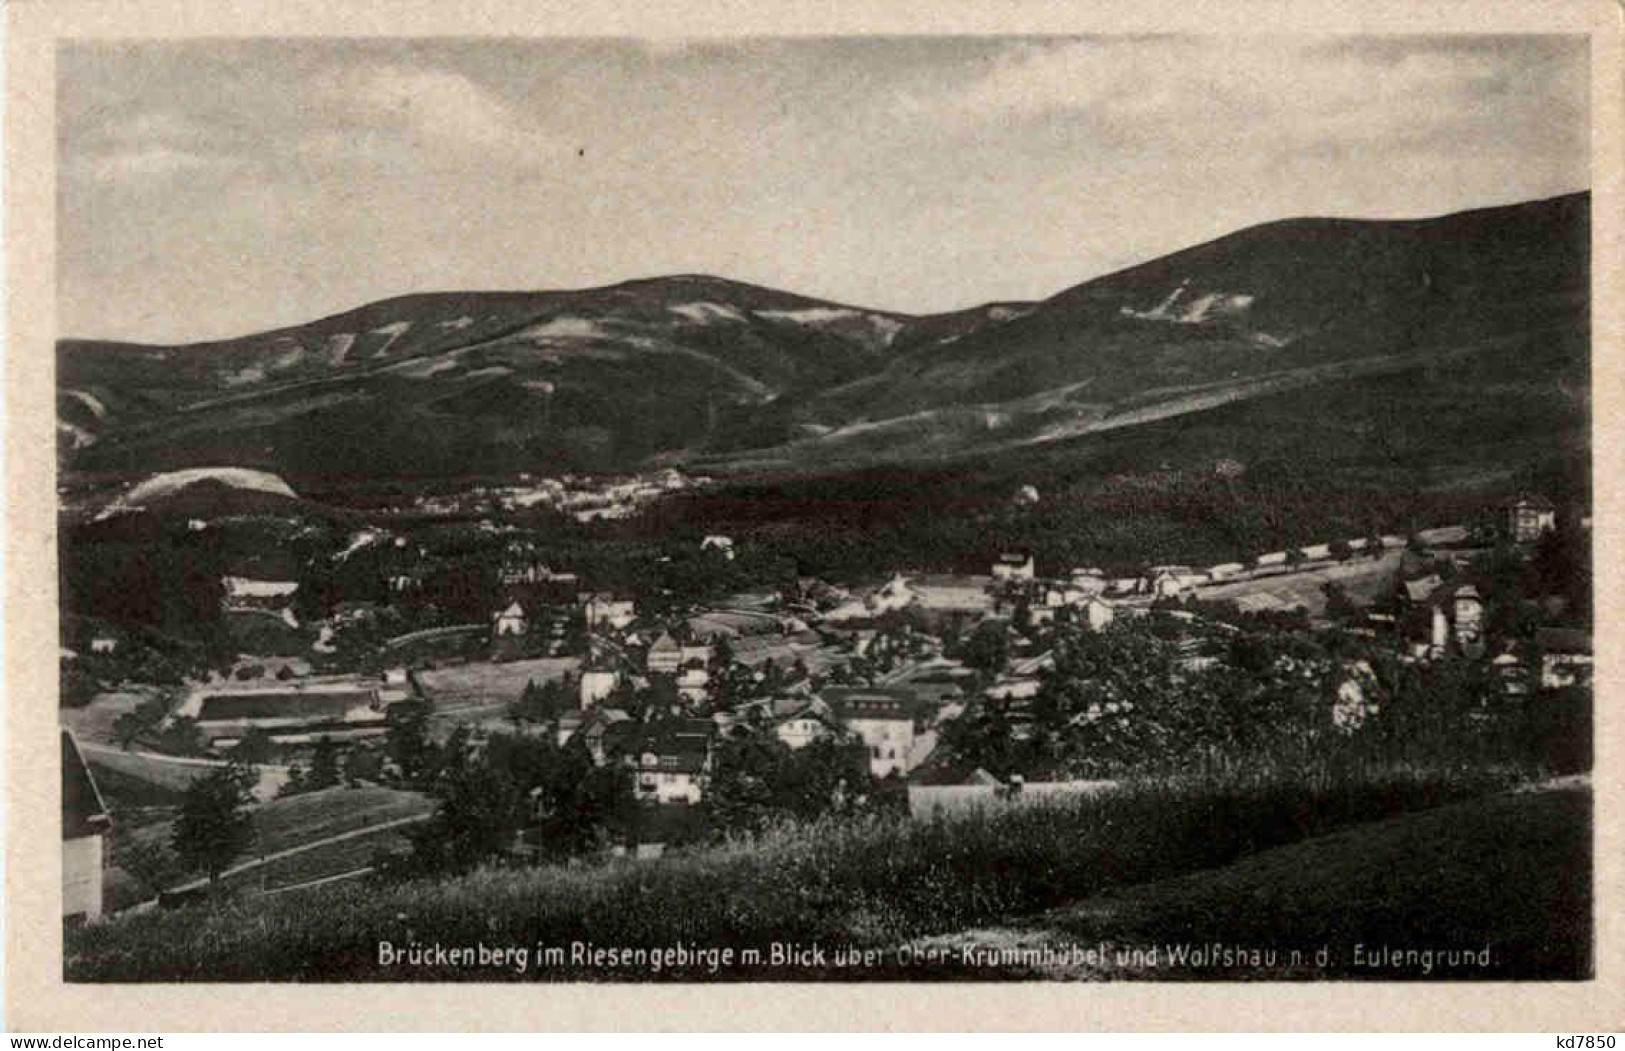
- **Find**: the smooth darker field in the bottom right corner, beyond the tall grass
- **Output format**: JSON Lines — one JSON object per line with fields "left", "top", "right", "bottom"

{"left": 894, "top": 783, "right": 1593, "bottom": 981}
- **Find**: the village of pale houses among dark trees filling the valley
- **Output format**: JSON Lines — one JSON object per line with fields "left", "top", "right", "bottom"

{"left": 62, "top": 464, "right": 1591, "bottom": 921}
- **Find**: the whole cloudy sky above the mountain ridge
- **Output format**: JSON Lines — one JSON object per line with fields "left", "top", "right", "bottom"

{"left": 59, "top": 37, "right": 1589, "bottom": 341}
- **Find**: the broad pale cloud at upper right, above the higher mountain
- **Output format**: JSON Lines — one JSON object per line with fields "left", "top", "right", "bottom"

{"left": 897, "top": 37, "right": 1584, "bottom": 159}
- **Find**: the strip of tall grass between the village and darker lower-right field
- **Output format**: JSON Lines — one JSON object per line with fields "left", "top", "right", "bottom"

{"left": 65, "top": 767, "right": 1534, "bottom": 981}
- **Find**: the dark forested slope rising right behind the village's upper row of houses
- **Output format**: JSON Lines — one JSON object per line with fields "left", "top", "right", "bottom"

{"left": 637, "top": 324, "right": 1589, "bottom": 580}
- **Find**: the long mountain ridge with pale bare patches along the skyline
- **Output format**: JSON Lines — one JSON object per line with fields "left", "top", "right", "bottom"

{"left": 57, "top": 192, "right": 1589, "bottom": 478}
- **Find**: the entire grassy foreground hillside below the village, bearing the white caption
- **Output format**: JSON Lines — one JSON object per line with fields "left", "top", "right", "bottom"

{"left": 65, "top": 772, "right": 1591, "bottom": 981}
